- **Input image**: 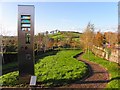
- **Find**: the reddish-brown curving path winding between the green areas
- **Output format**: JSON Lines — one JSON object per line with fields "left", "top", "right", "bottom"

{"left": 61, "top": 53, "right": 109, "bottom": 88}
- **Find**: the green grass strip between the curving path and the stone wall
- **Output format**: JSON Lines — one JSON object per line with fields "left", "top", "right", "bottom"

{"left": 82, "top": 52, "right": 120, "bottom": 88}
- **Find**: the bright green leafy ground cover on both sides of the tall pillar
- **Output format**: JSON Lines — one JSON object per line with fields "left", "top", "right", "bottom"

{"left": 0, "top": 50, "right": 88, "bottom": 86}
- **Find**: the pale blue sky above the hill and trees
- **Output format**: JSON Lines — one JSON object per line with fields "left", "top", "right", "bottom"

{"left": 0, "top": 2, "right": 118, "bottom": 35}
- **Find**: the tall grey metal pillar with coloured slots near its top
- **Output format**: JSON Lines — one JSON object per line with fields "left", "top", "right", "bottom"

{"left": 18, "top": 5, "right": 34, "bottom": 83}
